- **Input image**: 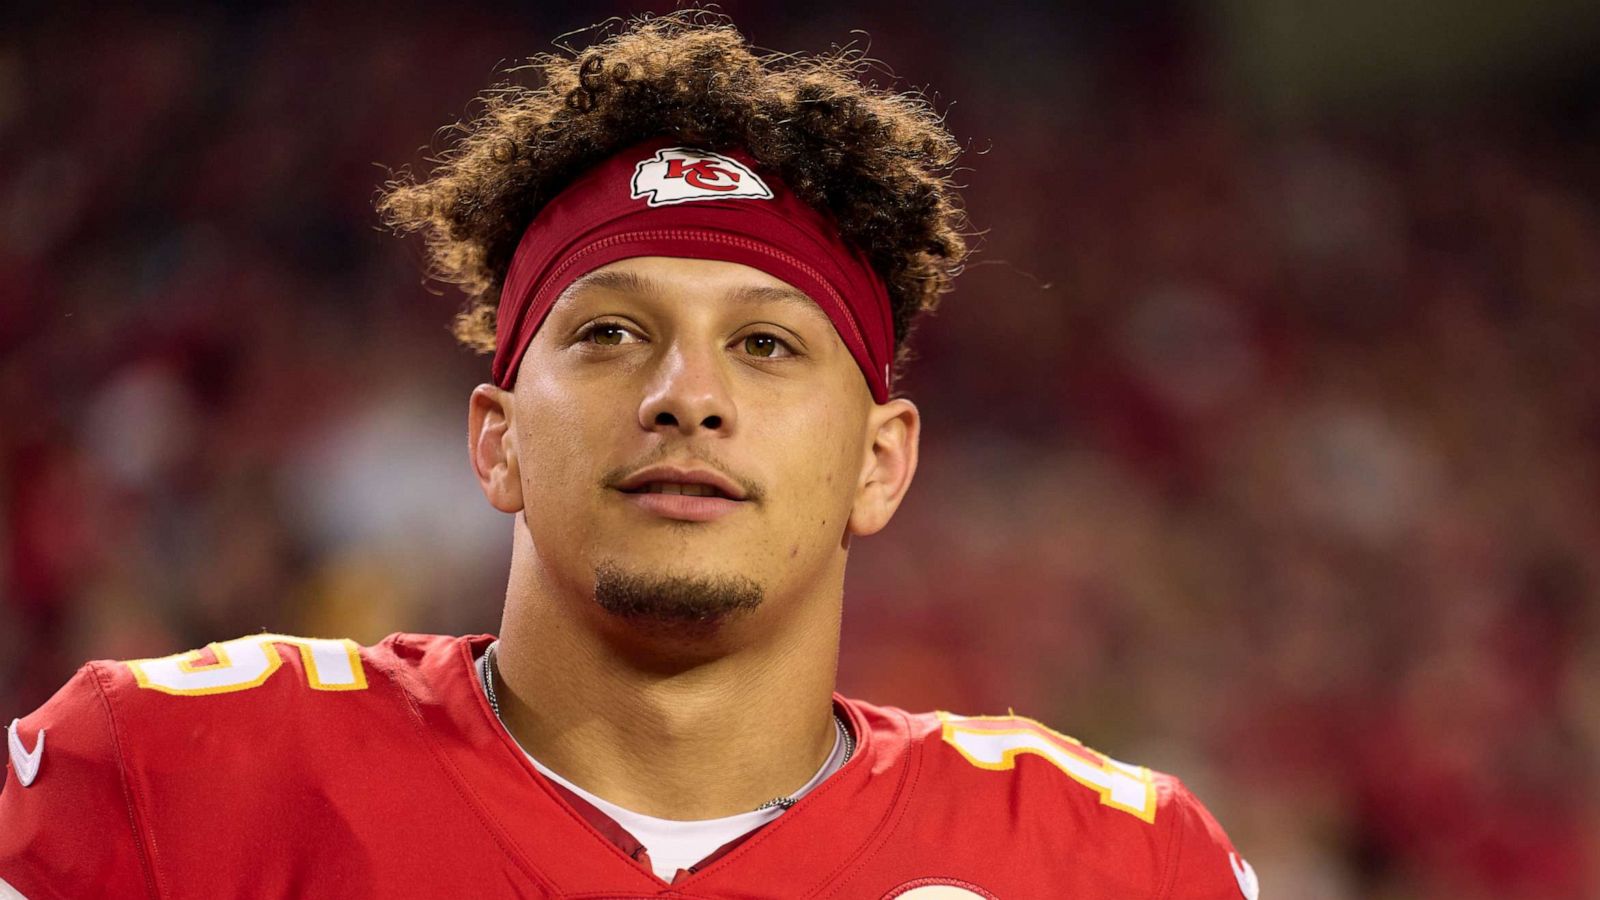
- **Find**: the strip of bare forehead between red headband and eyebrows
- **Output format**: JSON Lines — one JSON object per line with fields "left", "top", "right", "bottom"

{"left": 557, "top": 256, "right": 832, "bottom": 328}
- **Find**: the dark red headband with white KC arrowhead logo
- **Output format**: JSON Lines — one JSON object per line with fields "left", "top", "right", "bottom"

{"left": 493, "top": 138, "right": 894, "bottom": 404}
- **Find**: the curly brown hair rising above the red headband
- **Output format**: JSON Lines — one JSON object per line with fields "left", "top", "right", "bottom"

{"left": 378, "top": 10, "right": 968, "bottom": 377}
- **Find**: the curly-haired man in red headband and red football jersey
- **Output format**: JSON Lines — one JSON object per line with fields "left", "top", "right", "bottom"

{"left": 0, "top": 8, "right": 1256, "bottom": 900}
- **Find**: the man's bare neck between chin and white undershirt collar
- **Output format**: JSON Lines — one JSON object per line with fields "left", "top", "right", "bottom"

{"left": 496, "top": 517, "right": 843, "bottom": 820}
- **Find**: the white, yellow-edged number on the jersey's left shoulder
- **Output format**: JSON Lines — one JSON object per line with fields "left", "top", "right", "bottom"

{"left": 126, "top": 634, "right": 366, "bottom": 697}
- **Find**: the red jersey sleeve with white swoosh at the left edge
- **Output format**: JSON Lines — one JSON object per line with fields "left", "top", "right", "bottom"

{"left": 0, "top": 663, "right": 157, "bottom": 900}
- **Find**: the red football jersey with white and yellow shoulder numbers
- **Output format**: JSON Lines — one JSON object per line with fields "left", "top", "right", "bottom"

{"left": 0, "top": 634, "right": 1256, "bottom": 900}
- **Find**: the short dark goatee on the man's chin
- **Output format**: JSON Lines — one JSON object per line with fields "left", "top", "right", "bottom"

{"left": 595, "top": 560, "right": 765, "bottom": 631}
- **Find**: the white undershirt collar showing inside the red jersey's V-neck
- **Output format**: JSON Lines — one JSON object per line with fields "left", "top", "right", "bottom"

{"left": 477, "top": 643, "right": 845, "bottom": 881}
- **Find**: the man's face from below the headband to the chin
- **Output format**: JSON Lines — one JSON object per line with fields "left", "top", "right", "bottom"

{"left": 510, "top": 256, "right": 878, "bottom": 621}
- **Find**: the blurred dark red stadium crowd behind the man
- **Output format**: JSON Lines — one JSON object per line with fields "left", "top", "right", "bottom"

{"left": 0, "top": 0, "right": 1600, "bottom": 898}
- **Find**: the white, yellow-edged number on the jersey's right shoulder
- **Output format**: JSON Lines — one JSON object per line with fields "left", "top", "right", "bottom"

{"left": 939, "top": 713, "right": 1155, "bottom": 822}
